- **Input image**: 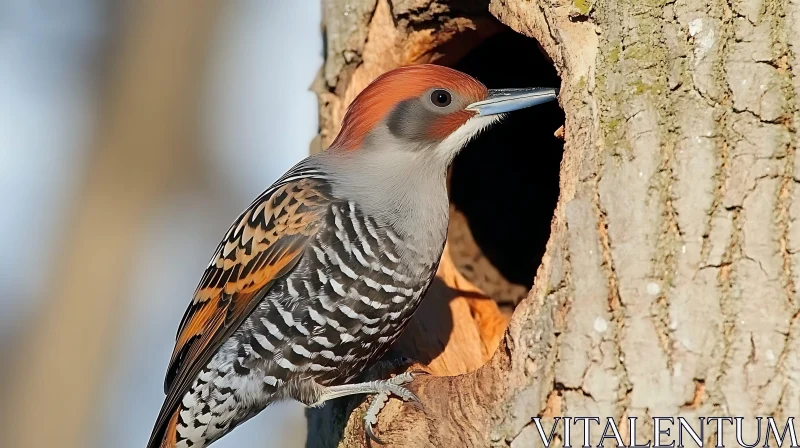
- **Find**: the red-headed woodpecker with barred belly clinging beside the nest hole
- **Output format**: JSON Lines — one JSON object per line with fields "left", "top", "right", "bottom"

{"left": 147, "top": 64, "right": 558, "bottom": 448}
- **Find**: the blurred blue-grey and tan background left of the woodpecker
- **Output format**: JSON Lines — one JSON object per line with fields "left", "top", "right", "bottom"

{"left": 0, "top": 0, "right": 322, "bottom": 448}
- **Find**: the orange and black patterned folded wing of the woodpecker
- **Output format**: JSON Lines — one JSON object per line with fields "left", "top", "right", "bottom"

{"left": 148, "top": 178, "right": 330, "bottom": 447}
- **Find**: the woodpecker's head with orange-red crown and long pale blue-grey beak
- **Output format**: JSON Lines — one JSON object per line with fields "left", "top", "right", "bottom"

{"left": 331, "top": 64, "right": 558, "bottom": 162}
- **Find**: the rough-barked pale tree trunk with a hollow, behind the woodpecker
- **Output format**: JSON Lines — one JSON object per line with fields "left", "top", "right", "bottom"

{"left": 308, "top": 0, "right": 800, "bottom": 447}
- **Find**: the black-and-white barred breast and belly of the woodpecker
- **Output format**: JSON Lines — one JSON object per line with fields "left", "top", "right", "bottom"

{"left": 241, "top": 201, "right": 438, "bottom": 389}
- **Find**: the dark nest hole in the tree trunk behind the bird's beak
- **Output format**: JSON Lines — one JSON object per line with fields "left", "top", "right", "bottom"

{"left": 450, "top": 30, "right": 564, "bottom": 311}
